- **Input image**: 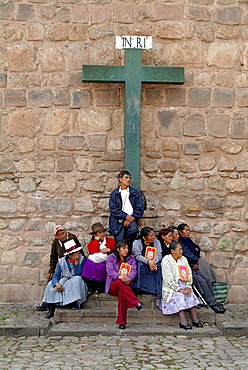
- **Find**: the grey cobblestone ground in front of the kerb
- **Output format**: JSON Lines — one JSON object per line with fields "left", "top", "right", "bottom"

{"left": 0, "top": 334, "right": 248, "bottom": 370}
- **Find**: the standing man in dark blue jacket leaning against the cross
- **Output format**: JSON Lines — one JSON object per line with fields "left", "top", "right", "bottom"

{"left": 109, "top": 171, "right": 144, "bottom": 249}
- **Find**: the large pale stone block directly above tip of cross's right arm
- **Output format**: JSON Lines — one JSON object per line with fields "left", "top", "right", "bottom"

{"left": 166, "top": 41, "right": 204, "bottom": 67}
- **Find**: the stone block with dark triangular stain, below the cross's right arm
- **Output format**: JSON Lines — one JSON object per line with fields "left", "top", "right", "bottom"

{"left": 157, "top": 109, "right": 181, "bottom": 137}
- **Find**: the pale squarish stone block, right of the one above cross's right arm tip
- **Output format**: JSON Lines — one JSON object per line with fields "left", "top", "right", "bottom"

{"left": 207, "top": 41, "right": 239, "bottom": 69}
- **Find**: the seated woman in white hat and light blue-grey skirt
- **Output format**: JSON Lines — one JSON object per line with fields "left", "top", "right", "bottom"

{"left": 43, "top": 239, "right": 87, "bottom": 319}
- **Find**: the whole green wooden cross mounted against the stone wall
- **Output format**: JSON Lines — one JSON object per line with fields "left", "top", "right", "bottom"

{"left": 82, "top": 49, "right": 184, "bottom": 188}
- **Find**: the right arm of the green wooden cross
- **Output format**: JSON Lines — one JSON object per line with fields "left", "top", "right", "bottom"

{"left": 142, "top": 66, "right": 184, "bottom": 84}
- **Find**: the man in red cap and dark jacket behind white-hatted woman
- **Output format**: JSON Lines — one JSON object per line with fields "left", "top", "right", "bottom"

{"left": 36, "top": 225, "right": 81, "bottom": 311}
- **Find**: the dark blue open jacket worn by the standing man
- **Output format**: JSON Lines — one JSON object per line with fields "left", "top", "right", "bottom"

{"left": 109, "top": 187, "right": 144, "bottom": 235}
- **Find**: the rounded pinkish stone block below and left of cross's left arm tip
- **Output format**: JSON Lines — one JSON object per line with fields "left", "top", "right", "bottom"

{"left": 44, "top": 109, "right": 74, "bottom": 135}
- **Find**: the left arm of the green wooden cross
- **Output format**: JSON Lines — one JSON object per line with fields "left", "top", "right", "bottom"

{"left": 82, "top": 64, "right": 126, "bottom": 82}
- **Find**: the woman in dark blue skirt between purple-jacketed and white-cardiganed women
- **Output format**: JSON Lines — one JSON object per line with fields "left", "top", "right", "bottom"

{"left": 132, "top": 227, "right": 162, "bottom": 298}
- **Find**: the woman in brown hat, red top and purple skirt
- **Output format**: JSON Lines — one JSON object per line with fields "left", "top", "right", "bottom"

{"left": 82, "top": 222, "right": 115, "bottom": 294}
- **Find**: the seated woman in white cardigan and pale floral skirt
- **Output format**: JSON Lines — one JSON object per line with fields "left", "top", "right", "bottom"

{"left": 157, "top": 241, "right": 203, "bottom": 330}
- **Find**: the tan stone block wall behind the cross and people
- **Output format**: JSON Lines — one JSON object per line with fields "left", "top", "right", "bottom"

{"left": 0, "top": 0, "right": 248, "bottom": 302}
